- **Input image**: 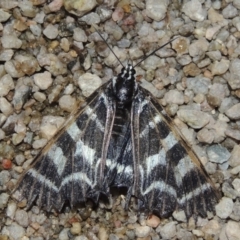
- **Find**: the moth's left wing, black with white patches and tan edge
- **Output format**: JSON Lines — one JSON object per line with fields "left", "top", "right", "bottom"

{"left": 16, "top": 83, "right": 115, "bottom": 210}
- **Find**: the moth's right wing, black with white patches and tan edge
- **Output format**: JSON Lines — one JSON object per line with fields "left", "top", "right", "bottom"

{"left": 131, "top": 86, "right": 218, "bottom": 218}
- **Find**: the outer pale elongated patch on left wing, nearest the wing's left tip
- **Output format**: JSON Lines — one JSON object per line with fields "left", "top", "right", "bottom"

{"left": 47, "top": 144, "right": 67, "bottom": 175}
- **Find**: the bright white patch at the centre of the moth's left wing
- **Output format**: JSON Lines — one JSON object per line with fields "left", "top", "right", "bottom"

{"left": 74, "top": 140, "right": 96, "bottom": 165}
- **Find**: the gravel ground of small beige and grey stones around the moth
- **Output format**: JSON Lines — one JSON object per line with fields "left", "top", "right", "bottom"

{"left": 0, "top": 0, "right": 240, "bottom": 240}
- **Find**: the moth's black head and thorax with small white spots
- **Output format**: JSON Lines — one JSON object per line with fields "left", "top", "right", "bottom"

{"left": 112, "top": 64, "right": 136, "bottom": 106}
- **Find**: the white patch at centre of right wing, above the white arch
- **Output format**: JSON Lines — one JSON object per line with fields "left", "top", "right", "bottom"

{"left": 146, "top": 148, "right": 166, "bottom": 175}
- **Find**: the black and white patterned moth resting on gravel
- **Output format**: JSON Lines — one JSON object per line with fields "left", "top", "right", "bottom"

{"left": 16, "top": 34, "right": 218, "bottom": 219}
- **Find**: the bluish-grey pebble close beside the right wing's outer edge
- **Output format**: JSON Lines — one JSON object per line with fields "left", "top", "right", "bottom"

{"left": 207, "top": 144, "right": 231, "bottom": 164}
